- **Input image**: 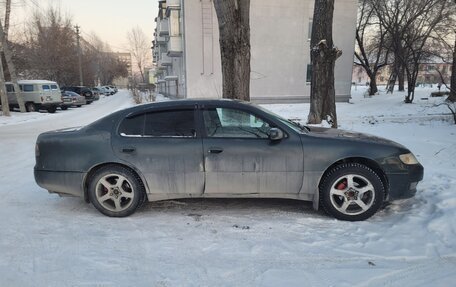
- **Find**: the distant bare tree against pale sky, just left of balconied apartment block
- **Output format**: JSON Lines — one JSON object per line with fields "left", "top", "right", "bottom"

{"left": 127, "top": 27, "right": 151, "bottom": 83}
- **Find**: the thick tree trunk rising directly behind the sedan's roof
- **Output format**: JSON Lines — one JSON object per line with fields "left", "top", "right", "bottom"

{"left": 214, "top": 0, "right": 250, "bottom": 101}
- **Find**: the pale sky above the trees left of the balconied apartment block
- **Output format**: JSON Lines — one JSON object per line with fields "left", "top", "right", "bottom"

{"left": 9, "top": 0, "right": 158, "bottom": 52}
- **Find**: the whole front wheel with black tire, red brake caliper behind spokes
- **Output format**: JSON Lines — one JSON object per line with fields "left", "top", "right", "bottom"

{"left": 320, "top": 163, "right": 385, "bottom": 221}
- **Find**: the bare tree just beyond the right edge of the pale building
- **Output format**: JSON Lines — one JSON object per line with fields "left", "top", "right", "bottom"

{"left": 355, "top": 0, "right": 389, "bottom": 95}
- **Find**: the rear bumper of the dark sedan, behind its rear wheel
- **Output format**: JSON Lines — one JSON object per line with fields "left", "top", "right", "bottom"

{"left": 34, "top": 168, "right": 86, "bottom": 197}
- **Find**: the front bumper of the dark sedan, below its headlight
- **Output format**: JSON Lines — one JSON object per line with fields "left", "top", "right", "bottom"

{"left": 387, "top": 164, "right": 424, "bottom": 200}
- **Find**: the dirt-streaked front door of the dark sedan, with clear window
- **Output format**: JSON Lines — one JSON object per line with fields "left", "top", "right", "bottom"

{"left": 201, "top": 106, "right": 303, "bottom": 197}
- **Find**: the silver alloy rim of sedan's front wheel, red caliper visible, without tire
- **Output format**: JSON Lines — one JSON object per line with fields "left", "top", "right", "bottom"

{"left": 329, "top": 174, "right": 375, "bottom": 215}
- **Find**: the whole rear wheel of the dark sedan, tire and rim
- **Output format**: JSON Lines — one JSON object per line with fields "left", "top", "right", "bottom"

{"left": 88, "top": 165, "right": 145, "bottom": 217}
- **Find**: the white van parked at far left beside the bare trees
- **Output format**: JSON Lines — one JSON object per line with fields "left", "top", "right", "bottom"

{"left": 6, "top": 80, "right": 62, "bottom": 113}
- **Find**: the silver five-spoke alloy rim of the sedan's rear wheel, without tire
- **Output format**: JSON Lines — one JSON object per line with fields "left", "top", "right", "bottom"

{"left": 95, "top": 174, "right": 134, "bottom": 212}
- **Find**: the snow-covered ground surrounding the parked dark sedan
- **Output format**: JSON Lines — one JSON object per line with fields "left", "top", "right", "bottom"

{"left": 0, "top": 87, "right": 456, "bottom": 286}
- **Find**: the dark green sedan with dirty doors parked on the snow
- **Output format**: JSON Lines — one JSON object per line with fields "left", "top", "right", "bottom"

{"left": 35, "top": 100, "right": 423, "bottom": 221}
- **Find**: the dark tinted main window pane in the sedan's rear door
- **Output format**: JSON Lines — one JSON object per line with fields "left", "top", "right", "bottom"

{"left": 144, "top": 110, "right": 196, "bottom": 137}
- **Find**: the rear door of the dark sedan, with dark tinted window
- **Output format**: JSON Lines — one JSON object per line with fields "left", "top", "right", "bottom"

{"left": 113, "top": 108, "right": 204, "bottom": 199}
